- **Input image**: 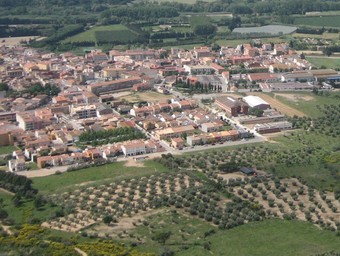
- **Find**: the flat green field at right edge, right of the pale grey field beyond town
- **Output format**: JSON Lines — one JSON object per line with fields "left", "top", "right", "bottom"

{"left": 294, "top": 15, "right": 340, "bottom": 27}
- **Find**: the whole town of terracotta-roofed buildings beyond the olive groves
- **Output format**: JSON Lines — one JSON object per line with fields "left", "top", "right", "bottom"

{"left": 0, "top": 40, "right": 340, "bottom": 172}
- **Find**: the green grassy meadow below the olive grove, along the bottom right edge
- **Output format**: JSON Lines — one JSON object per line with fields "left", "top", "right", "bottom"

{"left": 129, "top": 210, "right": 340, "bottom": 256}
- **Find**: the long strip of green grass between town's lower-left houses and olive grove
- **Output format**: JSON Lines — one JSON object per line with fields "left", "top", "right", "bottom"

{"left": 32, "top": 161, "right": 167, "bottom": 193}
